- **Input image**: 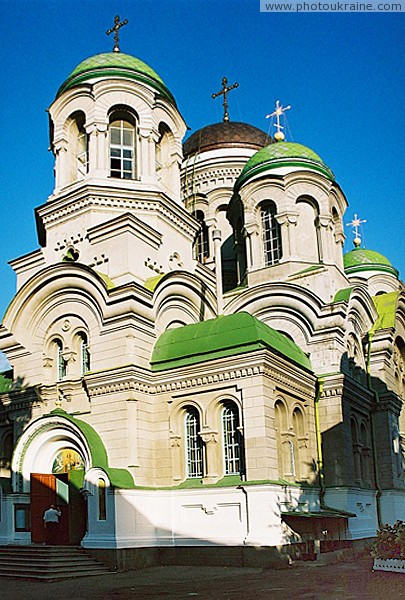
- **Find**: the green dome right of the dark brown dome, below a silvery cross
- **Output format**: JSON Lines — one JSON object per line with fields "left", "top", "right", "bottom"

{"left": 236, "top": 142, "right": 334, "bottom": 189}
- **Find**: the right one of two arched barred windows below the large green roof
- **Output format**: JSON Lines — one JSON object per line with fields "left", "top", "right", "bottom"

{"left": 222, "top": 402, "right": 242, "bottom": 475}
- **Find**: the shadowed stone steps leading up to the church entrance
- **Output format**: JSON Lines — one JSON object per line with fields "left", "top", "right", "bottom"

{"left": 0, "top": 545, "right": 113, "bottom": 581}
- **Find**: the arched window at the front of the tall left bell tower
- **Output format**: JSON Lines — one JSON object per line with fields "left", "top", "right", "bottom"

{"left": 109, "top": 110, "right": 136, "bottom": 179}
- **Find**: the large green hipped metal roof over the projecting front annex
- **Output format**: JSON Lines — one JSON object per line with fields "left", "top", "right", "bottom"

{"left": 151, "top": 312, "right": 312, "bottom": 371}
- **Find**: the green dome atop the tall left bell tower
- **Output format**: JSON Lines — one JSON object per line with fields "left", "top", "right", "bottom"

{"left": 56, "top": 52, "right": 176, "bottom": 105}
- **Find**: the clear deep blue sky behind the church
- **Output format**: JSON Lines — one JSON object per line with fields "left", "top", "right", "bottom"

{"left": 0, "top": 0, "right": 405, "bottom": 370}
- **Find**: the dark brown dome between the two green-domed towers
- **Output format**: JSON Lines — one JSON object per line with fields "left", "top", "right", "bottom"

{"left": 183, "top": 121, "right": 274, "bottom": 158}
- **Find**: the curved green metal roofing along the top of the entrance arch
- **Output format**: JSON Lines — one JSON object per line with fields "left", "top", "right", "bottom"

{"left": 50, "top": 408, "right": 135, "bottom": 489}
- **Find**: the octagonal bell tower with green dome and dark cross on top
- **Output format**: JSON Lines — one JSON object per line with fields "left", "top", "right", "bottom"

{"left": 13, "top": 18, "right": 198, "bottom": 294}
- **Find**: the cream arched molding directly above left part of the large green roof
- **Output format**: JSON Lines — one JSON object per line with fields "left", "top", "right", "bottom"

{"left": 154, "top": 271, "right": 216, "bottom": 336}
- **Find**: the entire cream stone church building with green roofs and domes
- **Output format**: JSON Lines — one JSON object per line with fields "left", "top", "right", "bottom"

{"left": 0, "top": 32, "right": 405, "bottom": 568}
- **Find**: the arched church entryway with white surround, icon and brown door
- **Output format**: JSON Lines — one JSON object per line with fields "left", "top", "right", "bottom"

{"left": 12, "top": 409, "right": 96, "bottom": 545}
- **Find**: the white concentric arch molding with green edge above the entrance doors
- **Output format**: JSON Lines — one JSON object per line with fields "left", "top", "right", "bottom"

{"left": 11, "top": 409, "right": 98, "bottom": 493}
